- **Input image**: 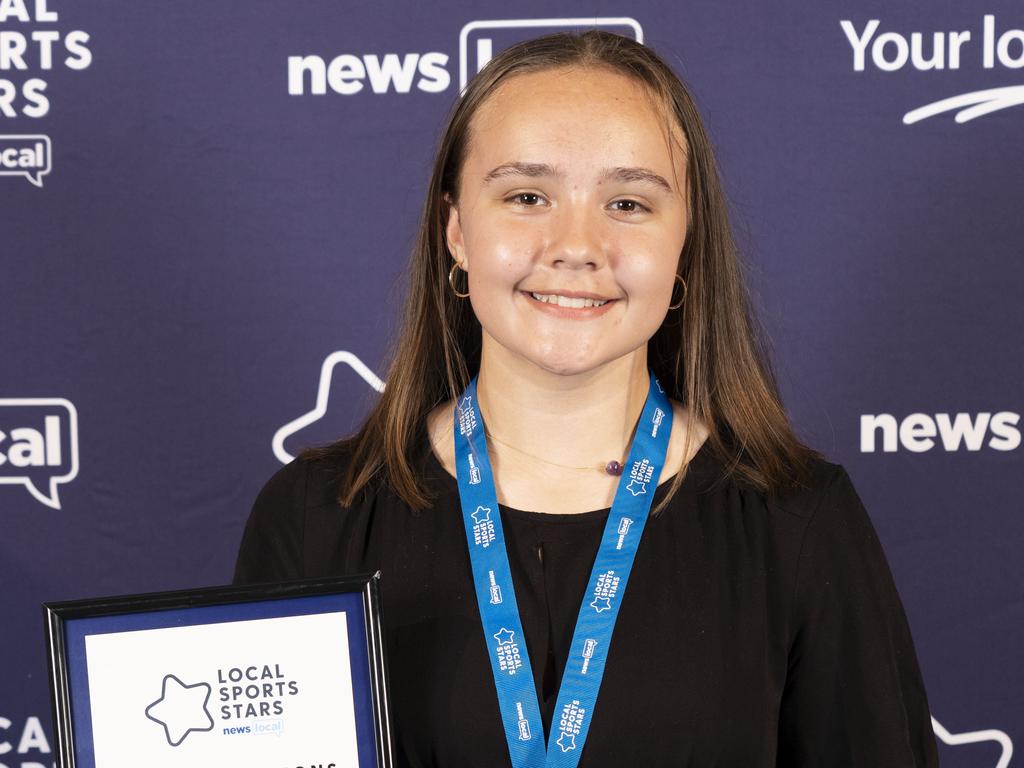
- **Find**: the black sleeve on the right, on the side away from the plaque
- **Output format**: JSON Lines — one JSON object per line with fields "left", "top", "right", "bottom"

{"left": 776, "top": 466, "right": 939, "bottom": 768}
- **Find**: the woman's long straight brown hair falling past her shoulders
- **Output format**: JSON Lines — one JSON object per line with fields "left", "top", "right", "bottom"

{"left": 305, "top": 31, "right": 820, "bottom": 513}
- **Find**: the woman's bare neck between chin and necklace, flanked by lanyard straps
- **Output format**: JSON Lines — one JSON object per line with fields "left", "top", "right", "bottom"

{"left": 477, "top": 334, "right": 649, "bottom": 470}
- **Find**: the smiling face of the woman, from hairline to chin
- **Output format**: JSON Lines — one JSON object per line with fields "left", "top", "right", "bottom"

{"left": 446, "top": 68, "right": 687, "bottom": 375}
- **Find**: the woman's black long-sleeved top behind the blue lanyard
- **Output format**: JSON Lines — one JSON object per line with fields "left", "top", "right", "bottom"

{"left": 234, "top": 441, "right": 938, "bottom": 768}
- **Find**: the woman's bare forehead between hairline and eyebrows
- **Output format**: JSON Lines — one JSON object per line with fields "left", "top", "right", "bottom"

{"left": 466, "top": 67, "right": 686, "bottom": 182}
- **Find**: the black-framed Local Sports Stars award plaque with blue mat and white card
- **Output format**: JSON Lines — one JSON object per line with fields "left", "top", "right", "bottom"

{"left": 43, "top": 573, "right": 392, "bottom": 768}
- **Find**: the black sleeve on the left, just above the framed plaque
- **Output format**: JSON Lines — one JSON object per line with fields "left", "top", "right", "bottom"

{"left": 231, "top": 459, "right": 306, "bottom": 584}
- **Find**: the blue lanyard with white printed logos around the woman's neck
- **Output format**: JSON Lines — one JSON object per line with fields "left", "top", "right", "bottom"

{"left": 454, "top": 373, "right": 672, "bottom": 768}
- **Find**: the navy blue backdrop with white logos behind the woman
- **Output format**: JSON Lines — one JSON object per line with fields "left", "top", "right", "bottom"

{"left": 0, "top": 0, "right": 1024, "bottom": 768}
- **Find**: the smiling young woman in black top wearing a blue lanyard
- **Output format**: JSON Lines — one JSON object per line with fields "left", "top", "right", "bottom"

{"left": 236, "top": 32, "right": 937, "bottom": 768}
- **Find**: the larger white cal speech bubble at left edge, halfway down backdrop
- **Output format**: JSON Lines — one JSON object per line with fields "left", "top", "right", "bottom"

{"left": 0, "top": 397, "right": 78, "bottom": 509}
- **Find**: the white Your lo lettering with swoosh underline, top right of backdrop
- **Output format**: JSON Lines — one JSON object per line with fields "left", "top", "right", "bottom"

{"left": 840, "top": 13, "right": 1024, "bottom": 125}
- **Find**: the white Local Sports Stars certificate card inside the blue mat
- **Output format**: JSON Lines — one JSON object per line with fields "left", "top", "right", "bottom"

{"left": 85, "top": 611, "right": 358, "bottom": 768}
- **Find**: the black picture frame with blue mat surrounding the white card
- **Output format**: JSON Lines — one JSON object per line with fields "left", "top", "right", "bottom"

{"left": 42, "top": 571, "right": 393, "bottom": 768}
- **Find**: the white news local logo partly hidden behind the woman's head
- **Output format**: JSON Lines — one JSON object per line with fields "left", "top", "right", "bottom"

{"left": 288, "top": 16, "right": 643, "bottom": 96}
